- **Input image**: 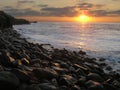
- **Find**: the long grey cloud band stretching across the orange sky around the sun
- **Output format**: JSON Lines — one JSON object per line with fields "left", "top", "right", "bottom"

{"left": 3, "top": 3, "right": 120, "bottom": 17}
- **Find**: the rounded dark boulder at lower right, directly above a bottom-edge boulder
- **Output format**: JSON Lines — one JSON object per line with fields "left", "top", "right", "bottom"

{"left": 87, "top": 73, "right": 104, "bottom": 82}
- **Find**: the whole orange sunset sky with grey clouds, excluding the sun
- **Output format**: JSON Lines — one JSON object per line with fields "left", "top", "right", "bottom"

{"left": 0, "top": 0, "right": 120, "bottom": 22}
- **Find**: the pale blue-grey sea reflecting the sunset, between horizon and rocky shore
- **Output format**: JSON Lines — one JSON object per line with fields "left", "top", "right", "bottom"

{"left": 14, "top": 22, "right": 120, "bottom": 70}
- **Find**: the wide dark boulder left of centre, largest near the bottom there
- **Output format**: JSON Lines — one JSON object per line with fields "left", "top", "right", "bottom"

{"left": 33, "top": 68, "right": 58, "bottom": 79}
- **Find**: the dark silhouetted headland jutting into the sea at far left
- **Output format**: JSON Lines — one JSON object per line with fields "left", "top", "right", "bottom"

{"left": 0, "top": 11, "right": 30, "bottom": 29}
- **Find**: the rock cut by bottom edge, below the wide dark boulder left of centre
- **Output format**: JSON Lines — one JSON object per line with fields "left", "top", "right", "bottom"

{"left": 39, "top": 83, "right": 58, "bottom": 90}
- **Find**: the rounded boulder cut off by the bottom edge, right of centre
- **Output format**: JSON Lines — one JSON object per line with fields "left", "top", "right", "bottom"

{"left": 85, "top": 80, "right": 105, "bottom": 90}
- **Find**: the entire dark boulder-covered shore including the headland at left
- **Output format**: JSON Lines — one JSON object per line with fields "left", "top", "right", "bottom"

{"left": 0, "top": 11, "right": 120, "bottom": 90}
